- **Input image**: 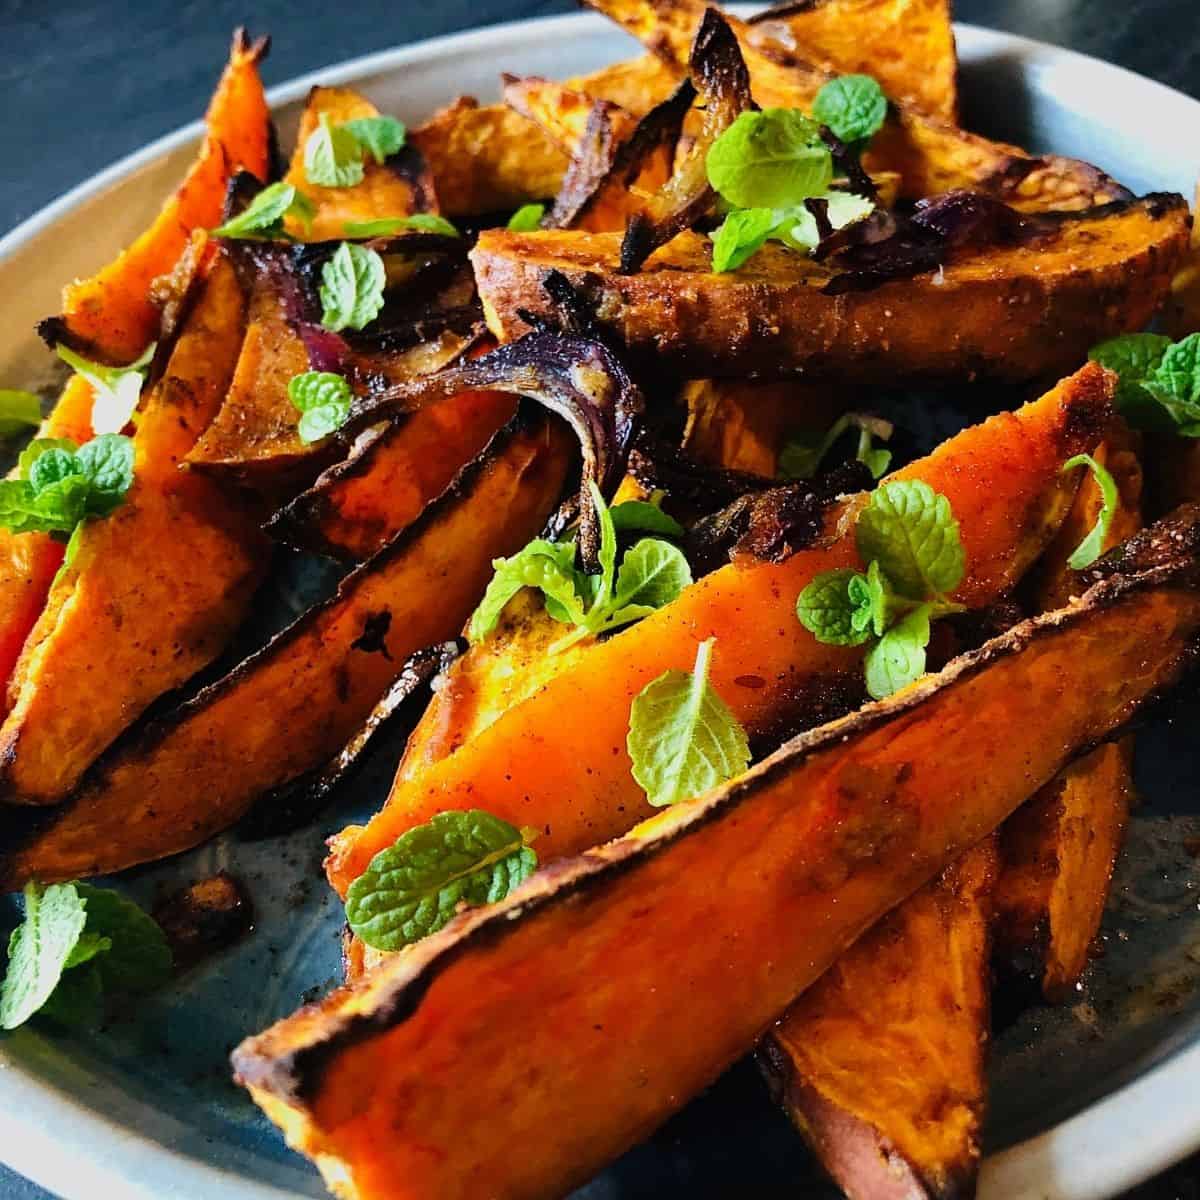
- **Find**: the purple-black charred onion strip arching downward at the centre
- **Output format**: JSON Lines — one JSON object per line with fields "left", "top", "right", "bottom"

{"left": 344, "top": 330, "right": 644, "bottom": 568}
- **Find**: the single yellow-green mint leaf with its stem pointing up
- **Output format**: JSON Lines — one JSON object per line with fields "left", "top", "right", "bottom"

{"left": 625, "top": 637, "right": 750, "bottom": 808}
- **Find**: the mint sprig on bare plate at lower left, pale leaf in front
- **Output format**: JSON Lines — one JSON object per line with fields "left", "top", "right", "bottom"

{"left": 0, "top": 883, "right": 172, "bottom": 1030}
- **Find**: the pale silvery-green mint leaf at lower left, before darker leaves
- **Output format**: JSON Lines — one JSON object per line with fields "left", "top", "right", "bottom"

{"left": 0, "top": 883, "right": 86, "bottom": 1030}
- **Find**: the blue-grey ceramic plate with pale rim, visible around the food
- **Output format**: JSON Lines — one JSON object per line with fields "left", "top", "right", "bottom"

{"left": 0, "top": 16, "right": 1200, "bottom": 1200}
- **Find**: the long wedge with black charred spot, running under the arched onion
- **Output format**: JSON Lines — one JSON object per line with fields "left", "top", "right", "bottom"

{"left": 0, "top": 421, "right": 572, "bottom": 890}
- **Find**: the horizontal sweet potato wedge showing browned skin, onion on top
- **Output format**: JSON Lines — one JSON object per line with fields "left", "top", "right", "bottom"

{"left": 472, "top": 197, "right": 1188, "bottom": 382}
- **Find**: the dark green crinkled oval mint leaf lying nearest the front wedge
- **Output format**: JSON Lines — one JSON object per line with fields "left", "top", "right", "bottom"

{"left": 346, "top": 809, "right": 538, "bottom": 950}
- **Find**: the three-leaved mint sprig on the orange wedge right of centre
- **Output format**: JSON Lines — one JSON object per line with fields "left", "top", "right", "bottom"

{"left": 796, "top": 480, "right": 966, "bottom": 700}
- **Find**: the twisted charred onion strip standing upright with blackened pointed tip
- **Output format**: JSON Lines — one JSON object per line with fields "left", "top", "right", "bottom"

{"left": 620, "top": 8, "right": 754, "bottom": 275}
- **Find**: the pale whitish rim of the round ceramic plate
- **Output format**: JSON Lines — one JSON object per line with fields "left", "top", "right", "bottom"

{"left": 0, "top": 11, "right": 1200, "bottom": 1200}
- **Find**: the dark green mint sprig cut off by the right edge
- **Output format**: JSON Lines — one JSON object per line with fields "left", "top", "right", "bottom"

{"left": 1088, "top": 334, "right": 1200, "bottom": 438}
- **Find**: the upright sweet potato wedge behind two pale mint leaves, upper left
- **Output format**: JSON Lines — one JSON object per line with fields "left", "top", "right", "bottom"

{"left": 284, "top": 88, "right": 438, "bottom": 241}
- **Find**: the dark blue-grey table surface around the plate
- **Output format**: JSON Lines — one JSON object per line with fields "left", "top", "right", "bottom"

{"left": 0, "top": 0, "right": 1200, "bottom": 1200}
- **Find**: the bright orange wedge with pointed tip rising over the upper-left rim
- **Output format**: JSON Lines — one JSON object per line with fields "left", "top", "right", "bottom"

{"left": 46, "top": 30, "right": 271, "bottom": 364}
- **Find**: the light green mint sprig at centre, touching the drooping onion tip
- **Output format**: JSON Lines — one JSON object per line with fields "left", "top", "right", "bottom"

{"left": 468, "top": 484, "right": 691, "bottom": 654}
